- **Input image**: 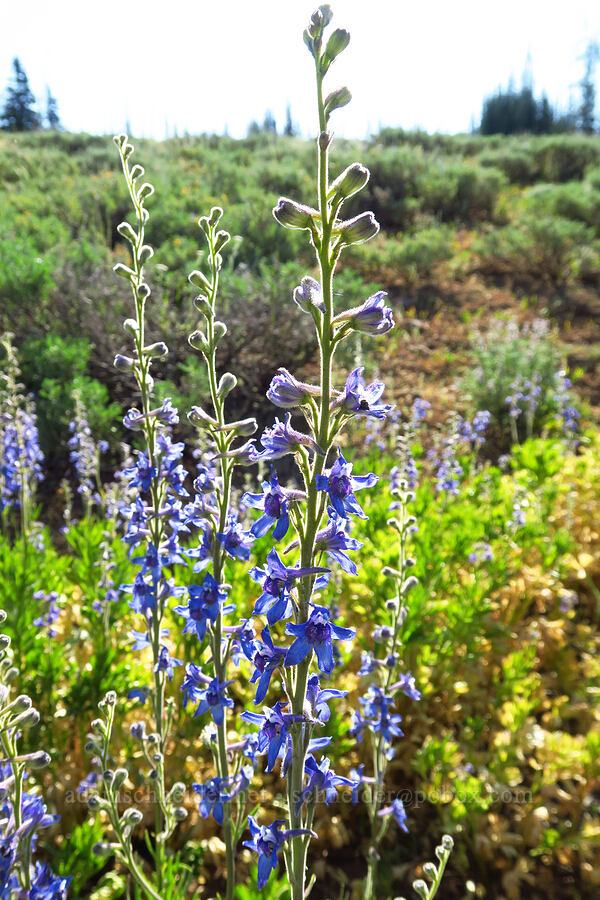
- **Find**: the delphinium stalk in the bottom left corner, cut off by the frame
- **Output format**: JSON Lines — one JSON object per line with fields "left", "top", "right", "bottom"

{"left": 0, "top": 610, "right": 71, "bottom": 900}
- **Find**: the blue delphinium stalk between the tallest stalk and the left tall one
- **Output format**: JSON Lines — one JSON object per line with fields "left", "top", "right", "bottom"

{"left": 175, "top": 207, "right": 268, "bottom": 900}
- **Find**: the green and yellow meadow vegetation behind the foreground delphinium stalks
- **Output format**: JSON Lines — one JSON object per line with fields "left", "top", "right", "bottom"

{"left": 0, "top": 65, "right": 600, "bottom": 900}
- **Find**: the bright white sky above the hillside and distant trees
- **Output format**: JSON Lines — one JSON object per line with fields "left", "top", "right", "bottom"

{"left": 0, "top": 0, "right": 600, "bottom": 138}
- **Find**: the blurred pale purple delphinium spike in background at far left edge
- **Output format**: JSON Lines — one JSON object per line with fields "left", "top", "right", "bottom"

{"left": 0, "top": 333, "right": 44, "bottom": 538}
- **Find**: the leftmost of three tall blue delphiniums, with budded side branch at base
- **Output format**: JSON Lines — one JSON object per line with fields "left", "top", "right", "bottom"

{"left": 86, "top": 135, "right": 189, "bottom": 897}
